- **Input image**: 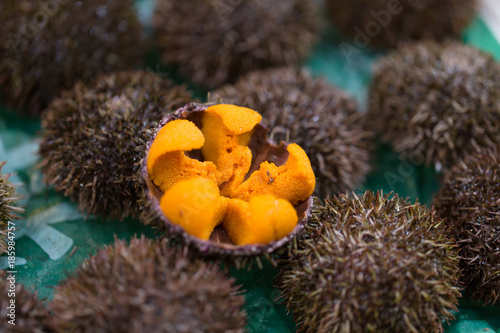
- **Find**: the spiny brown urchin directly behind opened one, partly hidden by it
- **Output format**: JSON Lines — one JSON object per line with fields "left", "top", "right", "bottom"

{"left": 211, "top": 68, "right": 372, "bottom": 196}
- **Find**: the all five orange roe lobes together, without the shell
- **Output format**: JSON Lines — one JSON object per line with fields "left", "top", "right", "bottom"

{"left": 147, "top": 104, "right": 316, "bottom": 245}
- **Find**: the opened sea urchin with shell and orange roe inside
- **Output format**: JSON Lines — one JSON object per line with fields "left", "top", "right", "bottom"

{"left": 142, "top": 103, "right": 316, "bottom": 265}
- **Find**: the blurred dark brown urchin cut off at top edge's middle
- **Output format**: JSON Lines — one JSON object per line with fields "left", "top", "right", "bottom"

{"left": 153, "top": 0, "right": 318, "bottom": 88}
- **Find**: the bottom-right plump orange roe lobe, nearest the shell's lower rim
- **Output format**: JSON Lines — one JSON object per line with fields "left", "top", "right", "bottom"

{"left": 223, "top": 194, "right": 298, "bottom": 245}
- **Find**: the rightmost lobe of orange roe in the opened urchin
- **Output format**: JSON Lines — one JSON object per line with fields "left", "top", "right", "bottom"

{"left": 232, "top": 143, "right": 316, "bottom": 205}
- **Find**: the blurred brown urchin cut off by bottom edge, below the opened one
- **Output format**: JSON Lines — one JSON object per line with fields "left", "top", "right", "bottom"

{"left": 49, "top": 236, "right": 246, "bottom": 333}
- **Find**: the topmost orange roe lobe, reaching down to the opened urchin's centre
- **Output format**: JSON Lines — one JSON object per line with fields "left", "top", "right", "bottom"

{"left": 201, "top": 104, "right": 262, "bottom": 196}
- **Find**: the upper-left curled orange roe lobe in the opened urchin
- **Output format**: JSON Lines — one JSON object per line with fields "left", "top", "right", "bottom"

{"left": 147, "top": 119, "right": 219, "bottom": 193}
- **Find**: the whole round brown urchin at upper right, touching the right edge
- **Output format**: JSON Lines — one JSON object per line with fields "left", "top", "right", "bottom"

{"left": 369, "top": 42, "right": 500, "bottom": 166}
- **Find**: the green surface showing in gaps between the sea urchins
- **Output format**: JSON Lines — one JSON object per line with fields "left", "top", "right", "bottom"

{"left": 0, "top": 1, "right": 500, "bottom": 333}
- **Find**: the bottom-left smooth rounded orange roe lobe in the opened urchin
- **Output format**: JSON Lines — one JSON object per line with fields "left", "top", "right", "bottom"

{"left": 160, "top": 177, "right": 228, "bottom": 240}
